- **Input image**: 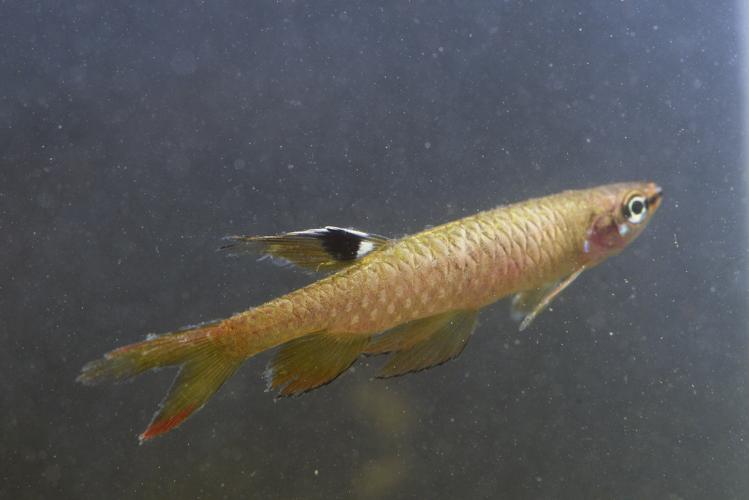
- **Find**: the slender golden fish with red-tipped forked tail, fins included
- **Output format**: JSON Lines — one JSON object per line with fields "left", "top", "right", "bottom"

{"left": 77, "top": 182, "right": 662, "bottom": 443}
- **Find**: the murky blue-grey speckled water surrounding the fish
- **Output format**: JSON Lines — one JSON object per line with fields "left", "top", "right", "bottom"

{"left": 0, "top": 0, "right": 749, "bottom": 499}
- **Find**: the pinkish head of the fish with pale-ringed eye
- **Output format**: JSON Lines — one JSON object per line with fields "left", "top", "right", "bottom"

{"left": 583, "top": 182, "right": 663, "bottom": 262}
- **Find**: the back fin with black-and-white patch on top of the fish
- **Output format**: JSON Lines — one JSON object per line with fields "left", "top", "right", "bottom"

{"left": 221, "top": 226, "right": 389, "bottom": 271}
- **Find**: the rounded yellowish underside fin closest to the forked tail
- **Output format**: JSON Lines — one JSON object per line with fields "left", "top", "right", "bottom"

{"left": 266, "top": 333, "right": 369, "bottom": 396}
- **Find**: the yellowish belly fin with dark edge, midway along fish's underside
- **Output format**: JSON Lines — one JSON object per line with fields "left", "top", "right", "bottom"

{"left": 366, "top": 311, "right": 478, "bottom": 378}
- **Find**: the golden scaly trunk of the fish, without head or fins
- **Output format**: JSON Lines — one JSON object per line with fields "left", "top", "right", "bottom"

{"left": 232, "top": 188, "right": 624, "bottom": 349}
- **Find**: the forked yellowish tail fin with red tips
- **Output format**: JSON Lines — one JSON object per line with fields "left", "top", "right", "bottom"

{"left": 77, "top": 324, "right": 243, "bottom": 443}
